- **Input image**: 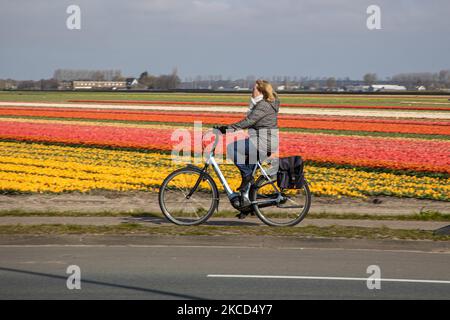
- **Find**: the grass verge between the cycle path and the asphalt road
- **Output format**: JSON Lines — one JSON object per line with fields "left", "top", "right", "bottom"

{"left": 0, "top": 223, "right": 450, "bottom": 241}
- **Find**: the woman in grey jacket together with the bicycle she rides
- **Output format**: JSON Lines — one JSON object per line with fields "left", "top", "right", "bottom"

{"left": 158, "top": 80, "right": 311, "bottom": 226}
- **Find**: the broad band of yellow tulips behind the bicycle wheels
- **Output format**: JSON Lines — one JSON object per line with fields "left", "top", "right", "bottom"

{"left": 0, "top": 142, "right": 450, "bottom": 201}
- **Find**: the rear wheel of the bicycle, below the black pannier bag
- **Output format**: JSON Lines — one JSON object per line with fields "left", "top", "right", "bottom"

{"left": 250, "top": 176, "right": 311, "bottom": 227}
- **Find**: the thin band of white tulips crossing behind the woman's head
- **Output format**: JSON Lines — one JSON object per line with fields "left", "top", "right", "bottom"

{"left": 0, "top": 101, "right": 450, "bottom": 119}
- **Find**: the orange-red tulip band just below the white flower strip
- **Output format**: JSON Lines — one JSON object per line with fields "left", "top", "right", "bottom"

{"left": 0, "top": 107, "right": 450, "bottom": 135}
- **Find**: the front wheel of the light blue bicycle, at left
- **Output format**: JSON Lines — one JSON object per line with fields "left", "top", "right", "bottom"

{"left": 159, "top": 168, "right": 219, "bottom": 226}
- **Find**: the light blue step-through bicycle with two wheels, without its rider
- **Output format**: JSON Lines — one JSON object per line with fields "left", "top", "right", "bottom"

{"left": 158, "top": 130, "right": 311, "bottom": 226}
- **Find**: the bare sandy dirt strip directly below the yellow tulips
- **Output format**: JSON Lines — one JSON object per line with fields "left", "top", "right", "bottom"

{"left": 0, "top": 191, "right": 450, "bottom": 215}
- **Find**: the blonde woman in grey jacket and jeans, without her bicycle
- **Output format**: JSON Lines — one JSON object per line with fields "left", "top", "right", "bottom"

{"left": 215, "top": 80, "right": 280, "bottom": 211}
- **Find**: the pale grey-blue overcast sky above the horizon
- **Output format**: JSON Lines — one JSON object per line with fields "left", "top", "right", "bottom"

{"left": 0, "top": 0, "right": 450, "bottom": 79}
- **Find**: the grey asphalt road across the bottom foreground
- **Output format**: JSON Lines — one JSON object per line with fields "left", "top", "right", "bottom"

{"left": 0, "top": 240, "right": 450, "bottom": 299}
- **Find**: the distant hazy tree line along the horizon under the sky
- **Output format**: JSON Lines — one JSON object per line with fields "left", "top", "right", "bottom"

{"left": 0, "top": 68, "right": 450, "bottom": 91}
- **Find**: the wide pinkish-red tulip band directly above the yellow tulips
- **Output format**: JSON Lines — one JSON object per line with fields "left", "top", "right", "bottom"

{"left": 0, "top": 121, "right": 450, "bottom": 173}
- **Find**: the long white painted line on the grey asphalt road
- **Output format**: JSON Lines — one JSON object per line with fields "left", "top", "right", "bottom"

{"left": 207, "top": 274, "right": 450, "bottom": 284}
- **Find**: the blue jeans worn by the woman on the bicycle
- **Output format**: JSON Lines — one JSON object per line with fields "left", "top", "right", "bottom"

{"left": 227, "top": 139, "right": 267, "bottom": 178}
